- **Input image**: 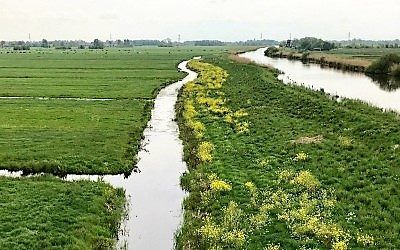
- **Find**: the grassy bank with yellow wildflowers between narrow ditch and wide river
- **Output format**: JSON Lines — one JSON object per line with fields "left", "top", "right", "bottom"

{"left": 178, "top": 57, "right": 400, "bottom": 250}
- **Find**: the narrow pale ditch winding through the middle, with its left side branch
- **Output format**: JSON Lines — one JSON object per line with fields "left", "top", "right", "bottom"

{"left": 0, "top": 61, "right": 197, "bottom": 250}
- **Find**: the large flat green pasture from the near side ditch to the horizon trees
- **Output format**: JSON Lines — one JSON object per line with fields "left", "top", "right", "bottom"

{"left": 0, "top": 47, "right": 245, "bottom": 174}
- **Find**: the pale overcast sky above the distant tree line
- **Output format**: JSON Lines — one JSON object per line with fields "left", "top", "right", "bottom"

{"left": 0, "top": 0, "right": 400, "bottom": 41}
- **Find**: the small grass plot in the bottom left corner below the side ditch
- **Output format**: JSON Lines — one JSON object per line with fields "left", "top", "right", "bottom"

{"left": 0, "top": 177, "right": 125, "bottom": 249}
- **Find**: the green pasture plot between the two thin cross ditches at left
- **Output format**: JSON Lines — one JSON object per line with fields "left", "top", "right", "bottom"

{"left": 0, "top": 99, "right": 152, "bottom": 175}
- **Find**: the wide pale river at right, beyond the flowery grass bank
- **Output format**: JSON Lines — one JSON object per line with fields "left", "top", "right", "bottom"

{"left": 241, "top": 48, "right": 400, "bottom": 112}
